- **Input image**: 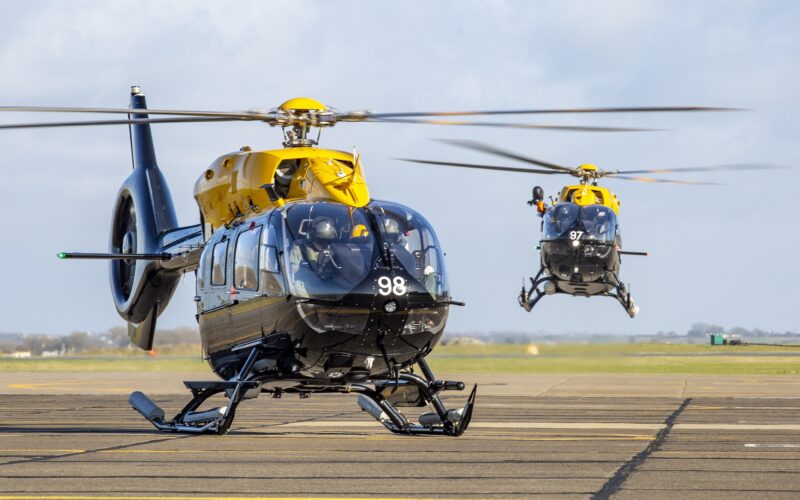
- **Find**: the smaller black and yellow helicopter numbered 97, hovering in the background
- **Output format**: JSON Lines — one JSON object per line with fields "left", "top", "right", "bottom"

{"left": 399, "top": 140, "right": 781, "bottom": 318}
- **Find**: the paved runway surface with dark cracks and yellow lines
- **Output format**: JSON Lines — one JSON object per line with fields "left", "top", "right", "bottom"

{"left": 0, "top": 373, "right": 800, "bottom": 500}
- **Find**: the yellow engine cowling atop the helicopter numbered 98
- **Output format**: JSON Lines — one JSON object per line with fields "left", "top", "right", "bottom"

{"left": 194, "top": 148, "right": 370, "bottom": 231}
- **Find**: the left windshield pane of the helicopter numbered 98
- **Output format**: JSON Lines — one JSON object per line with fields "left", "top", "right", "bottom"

{"left": 283, "top": 202, "right": 380, "bottom": 300}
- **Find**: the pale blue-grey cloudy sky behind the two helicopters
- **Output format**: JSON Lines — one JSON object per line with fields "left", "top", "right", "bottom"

{"left": 0, "top": 0, "right": 800, "bottom": 334}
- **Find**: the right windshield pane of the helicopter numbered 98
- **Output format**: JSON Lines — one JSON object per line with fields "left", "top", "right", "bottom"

{"left": 367, "top": 201, "right": 449, "bottom": 300}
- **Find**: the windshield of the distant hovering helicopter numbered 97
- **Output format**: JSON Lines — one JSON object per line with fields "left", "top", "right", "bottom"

{"left": 544, "top": 203, "right": 617, "bottom": 243}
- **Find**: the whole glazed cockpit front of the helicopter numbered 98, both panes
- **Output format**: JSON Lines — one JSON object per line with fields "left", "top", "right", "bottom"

{"left": 283, "top": 201, "right": 448, "bottom": 301}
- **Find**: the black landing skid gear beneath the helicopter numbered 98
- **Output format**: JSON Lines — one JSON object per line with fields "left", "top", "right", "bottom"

{"left": 128, "top": 346, "right": 478, "bottom": 436}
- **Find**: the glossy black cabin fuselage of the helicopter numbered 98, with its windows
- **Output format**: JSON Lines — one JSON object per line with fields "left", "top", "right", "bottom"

{"left": 196, "top": 202, "right": 449, "bottom": 384}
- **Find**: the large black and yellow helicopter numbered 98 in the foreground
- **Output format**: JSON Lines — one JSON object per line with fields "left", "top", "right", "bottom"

{"left": 0, "top": 87, "right": 736, "bottom": 436}
